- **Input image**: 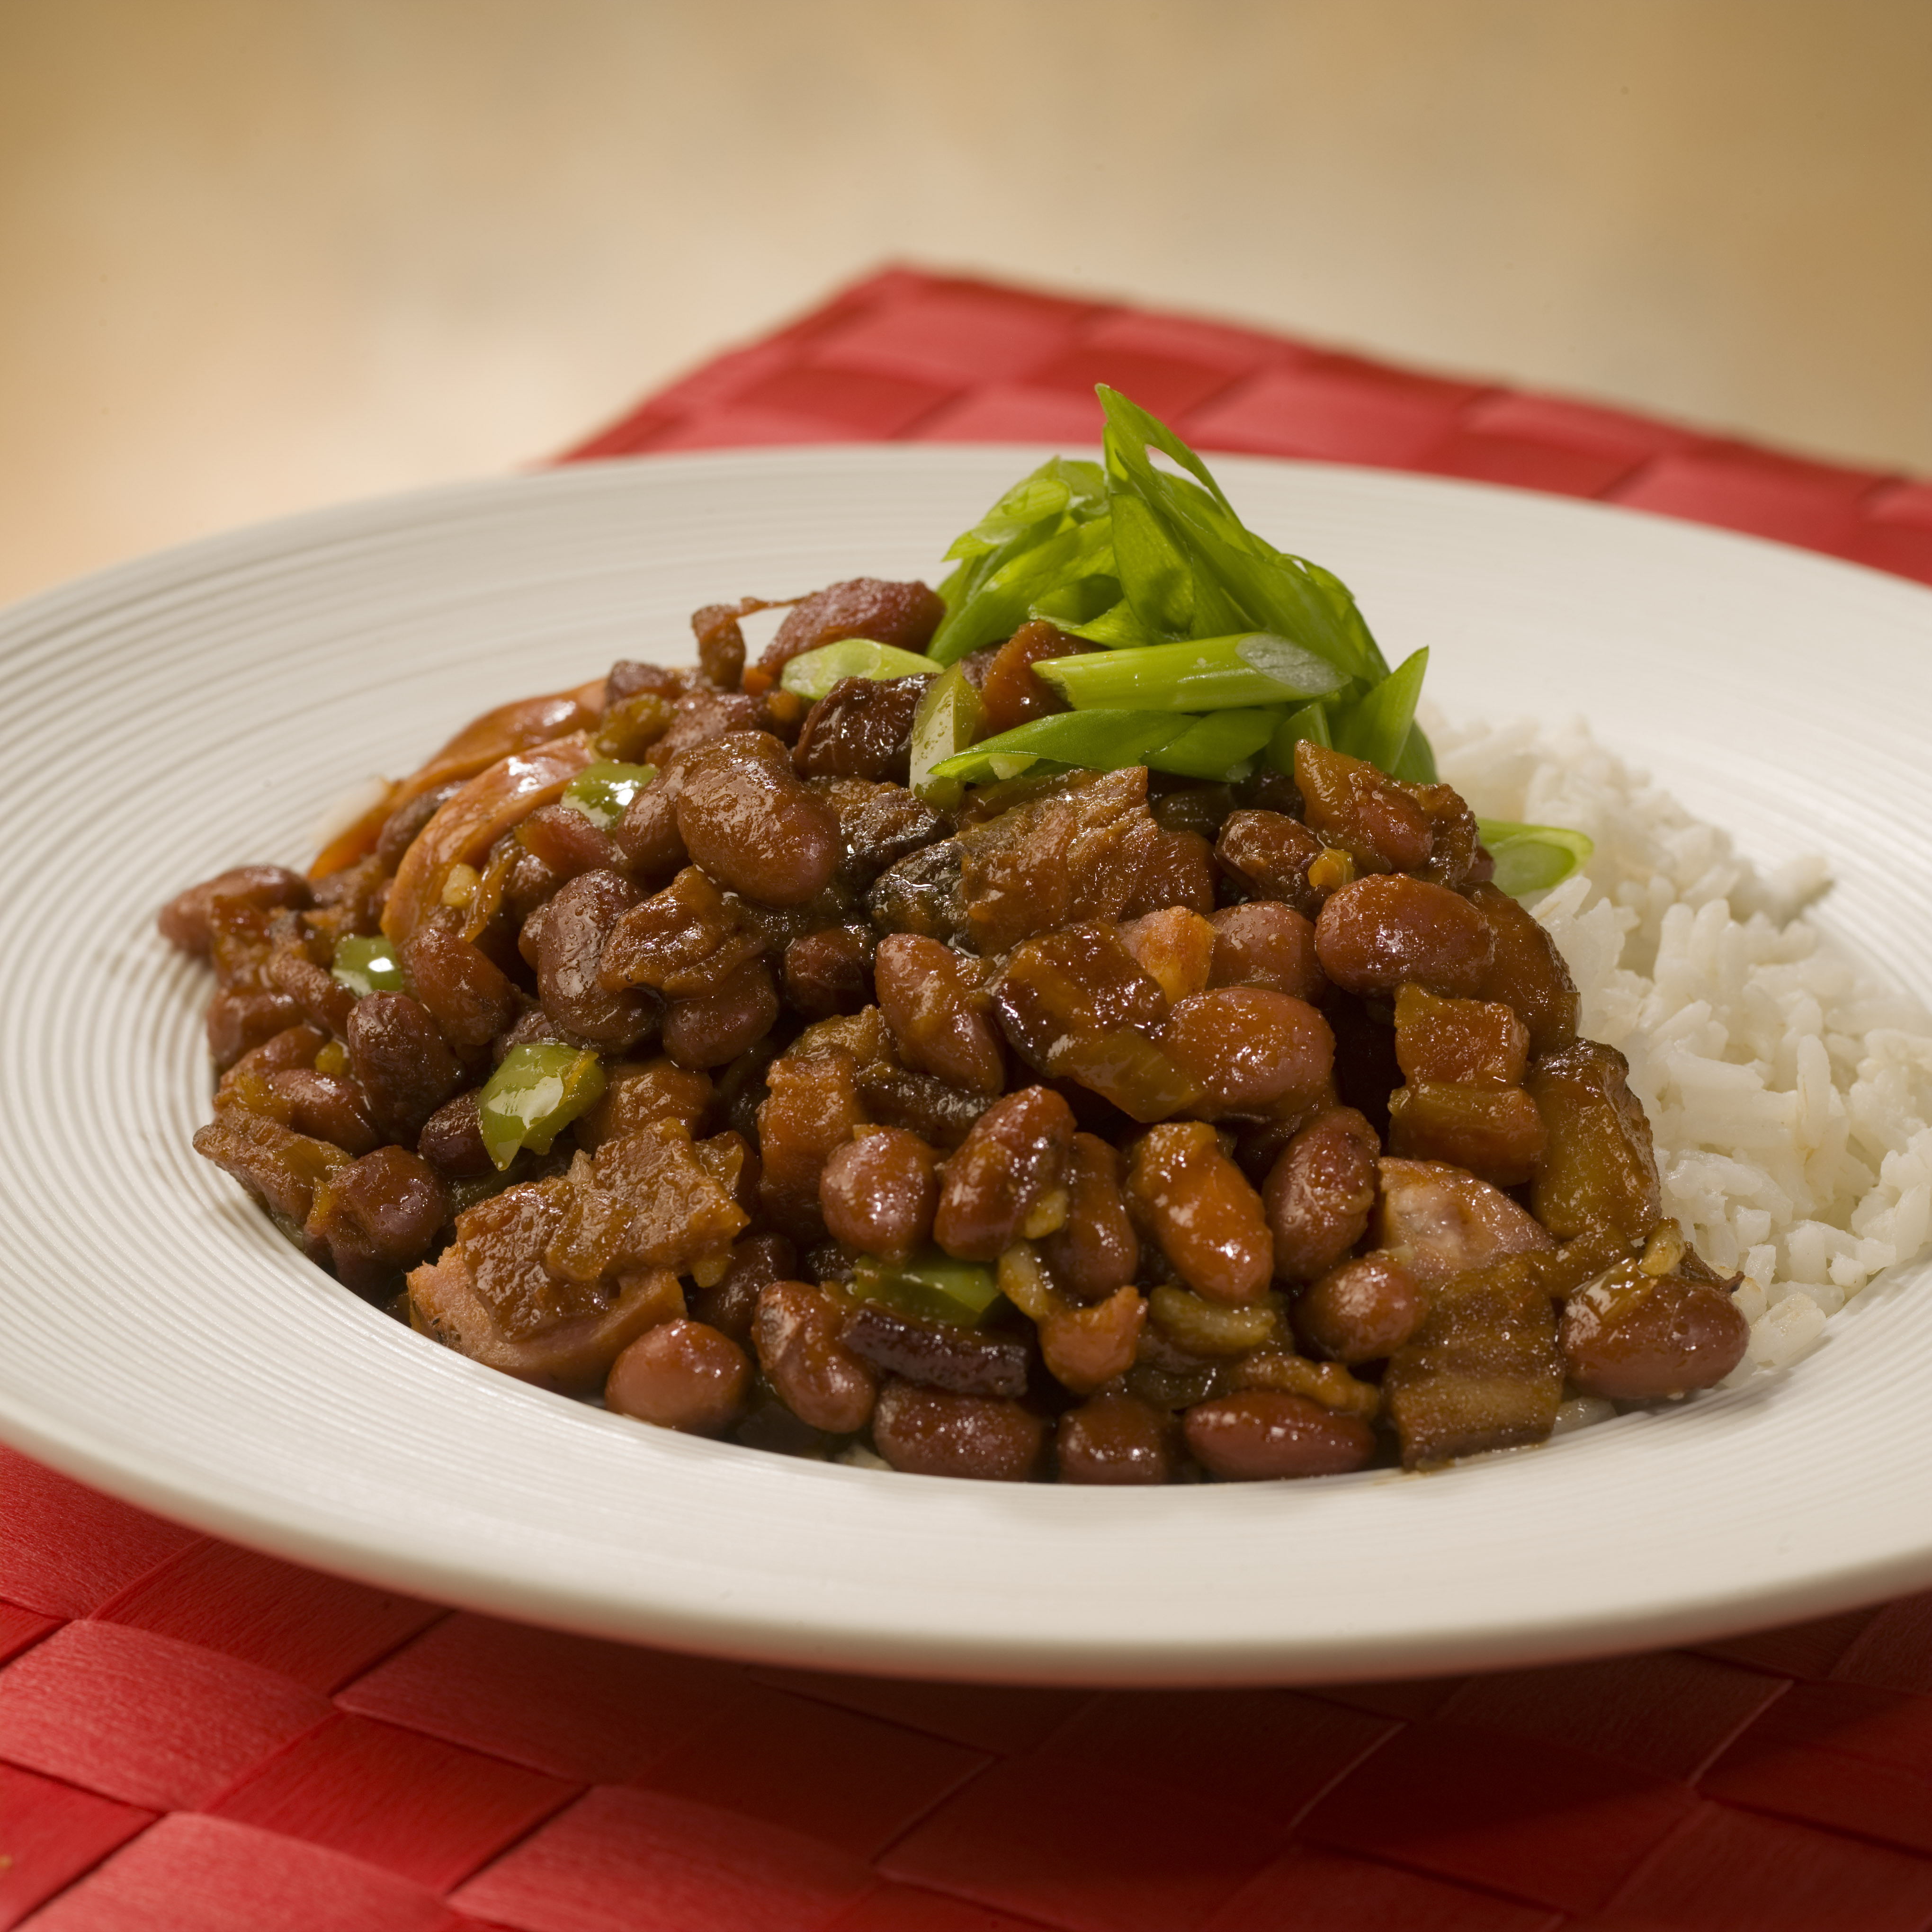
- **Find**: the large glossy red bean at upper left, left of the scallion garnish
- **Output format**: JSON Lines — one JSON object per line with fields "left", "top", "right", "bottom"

{"left": 678, "top": 732, "right": 839, "bottom": 906}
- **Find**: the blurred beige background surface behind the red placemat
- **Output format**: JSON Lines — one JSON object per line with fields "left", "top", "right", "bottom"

{"left": 0, "top": 0, "right": 1932, "bottom": 597}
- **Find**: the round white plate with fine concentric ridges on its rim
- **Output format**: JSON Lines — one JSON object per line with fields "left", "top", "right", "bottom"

{"left": 0, "top": 448, "right": 1932, "bottom": 1683}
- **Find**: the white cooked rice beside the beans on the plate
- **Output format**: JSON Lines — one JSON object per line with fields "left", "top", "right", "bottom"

{"left": 1430, "top": 719, "right": 1932, "bottom": 1383}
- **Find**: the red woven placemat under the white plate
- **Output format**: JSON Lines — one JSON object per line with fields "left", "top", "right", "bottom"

{"left": 11, "top": 270, "right": 1932, "bottom": 1932}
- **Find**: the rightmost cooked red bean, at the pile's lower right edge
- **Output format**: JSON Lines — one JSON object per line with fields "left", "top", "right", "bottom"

{"left": 1557, "top": 1265, "right": 1750, "bottom": 1403}
